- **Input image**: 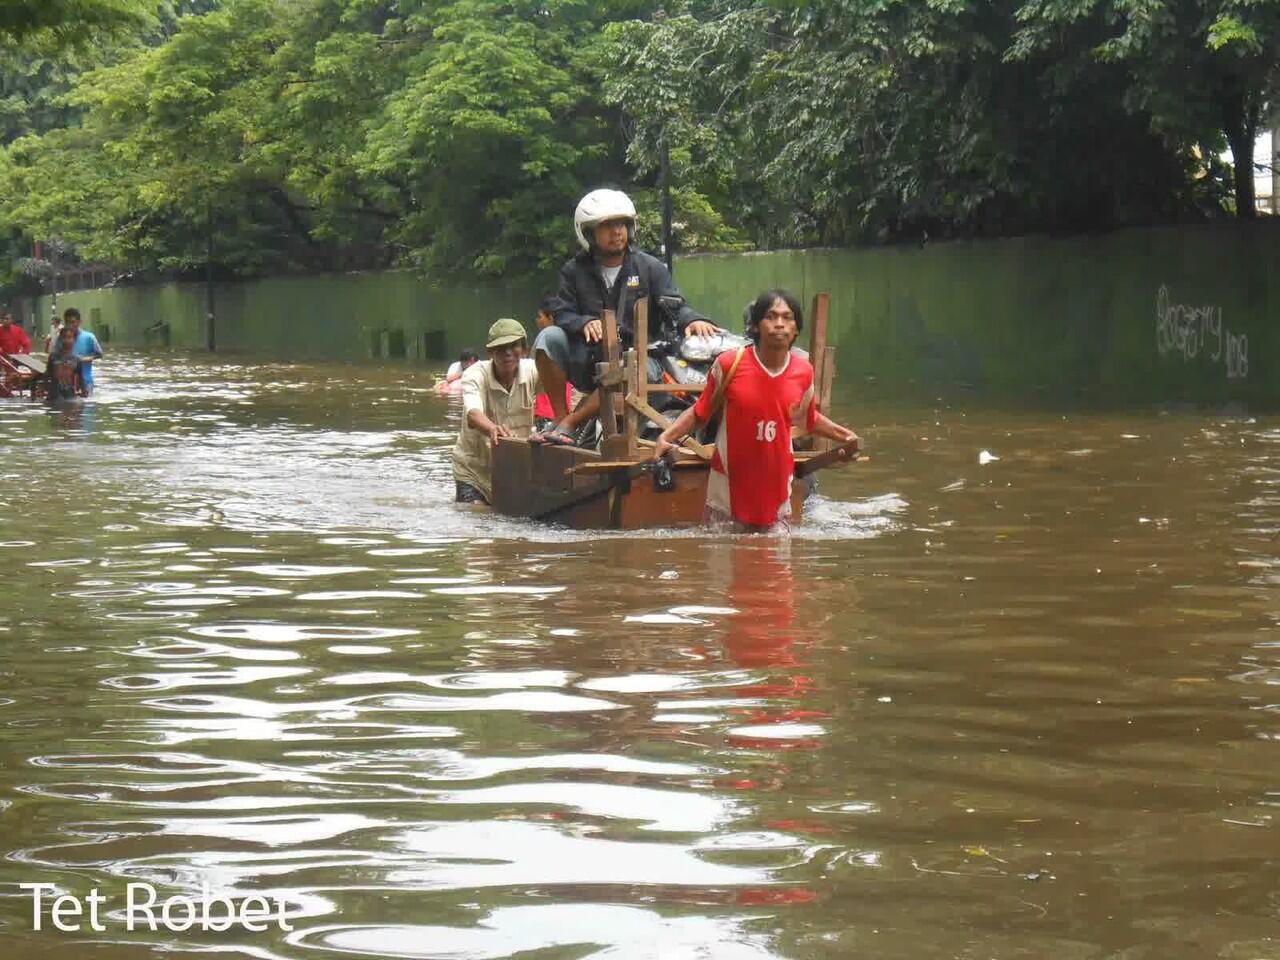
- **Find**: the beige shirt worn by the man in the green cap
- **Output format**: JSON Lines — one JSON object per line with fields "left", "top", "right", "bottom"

{"left": 453, "top": 360, "right": 541, "bottom": 500}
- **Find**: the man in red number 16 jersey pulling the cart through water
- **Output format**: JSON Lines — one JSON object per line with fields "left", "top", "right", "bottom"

{"left": 654, "top": 289, "right": 858, "bottom": 531}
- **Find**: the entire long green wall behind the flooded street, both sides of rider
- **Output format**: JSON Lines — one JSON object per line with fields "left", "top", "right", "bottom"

{"left": 17, "top": 220, "right": 1280, "bottom": 406}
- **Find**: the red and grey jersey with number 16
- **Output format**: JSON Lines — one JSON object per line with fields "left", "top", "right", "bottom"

{"left": 695, "top": 347, "right": 818, "bottom": 526}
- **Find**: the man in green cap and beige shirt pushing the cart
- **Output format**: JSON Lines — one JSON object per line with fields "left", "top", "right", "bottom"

{"left": 453, "top": 320, "right": 541, "bottom": 503}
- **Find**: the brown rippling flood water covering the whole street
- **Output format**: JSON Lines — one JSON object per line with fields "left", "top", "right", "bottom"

{"left": 0, "top": 352, "right": 1280, "bottom": 960}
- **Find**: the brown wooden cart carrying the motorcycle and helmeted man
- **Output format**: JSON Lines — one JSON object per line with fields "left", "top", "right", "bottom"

{"left": 493, "top": 293, "right": 836, "bottom": 530}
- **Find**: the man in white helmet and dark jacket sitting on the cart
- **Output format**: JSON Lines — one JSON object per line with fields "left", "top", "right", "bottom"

{"left": 534, "top": 189, "right": 716, "bottom": 443}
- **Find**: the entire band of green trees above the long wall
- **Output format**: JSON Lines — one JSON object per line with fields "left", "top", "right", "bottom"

{"left": 0, "top": 0, "right": 1280, "bottom": 296}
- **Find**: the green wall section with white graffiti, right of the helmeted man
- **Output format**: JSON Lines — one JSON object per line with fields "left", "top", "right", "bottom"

{"left": 676, "top": 221, "right": 1280, "bottom": 406}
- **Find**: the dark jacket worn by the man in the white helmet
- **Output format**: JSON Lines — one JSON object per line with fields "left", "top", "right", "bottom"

{"left": 554, "top": 250, "right": 707, "bottom": 352}
